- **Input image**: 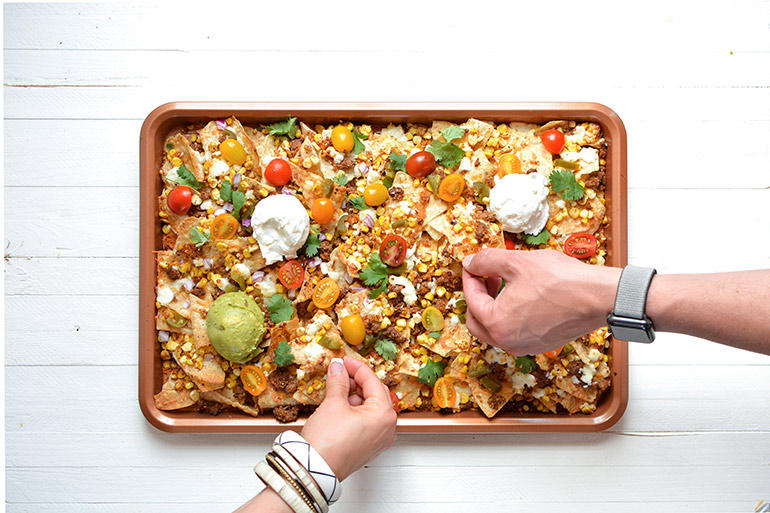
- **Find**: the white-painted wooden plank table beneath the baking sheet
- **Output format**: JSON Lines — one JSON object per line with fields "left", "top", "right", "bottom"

{"left": 4, "top": 0, "right": 770, "bottom": 513}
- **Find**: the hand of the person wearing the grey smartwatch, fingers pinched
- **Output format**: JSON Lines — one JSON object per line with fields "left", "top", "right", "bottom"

{"left": 463, "top": 249, "right": 621, "bottom": 355}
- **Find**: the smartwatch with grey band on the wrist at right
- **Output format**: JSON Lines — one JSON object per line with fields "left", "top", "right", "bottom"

{"left": 607, "top": 265, "right": 657, "bottom": 343}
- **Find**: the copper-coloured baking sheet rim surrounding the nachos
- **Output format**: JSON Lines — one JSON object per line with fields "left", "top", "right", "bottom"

{"left": 139, "top": 102, "right": 628, "bottom": 433}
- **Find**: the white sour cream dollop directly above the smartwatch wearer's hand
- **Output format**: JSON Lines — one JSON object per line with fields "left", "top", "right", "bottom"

{"left": 489, "top": 173, "right": 548, "bottom": 235}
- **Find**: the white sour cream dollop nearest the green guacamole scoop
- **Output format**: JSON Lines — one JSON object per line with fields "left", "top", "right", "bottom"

{"left": 251, "top": 194, "right": 310, "bottom": 265}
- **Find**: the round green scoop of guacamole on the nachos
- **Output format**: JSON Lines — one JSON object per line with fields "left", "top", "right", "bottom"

{"left": 206, "top": 292, "right": 265, "bottom": 363}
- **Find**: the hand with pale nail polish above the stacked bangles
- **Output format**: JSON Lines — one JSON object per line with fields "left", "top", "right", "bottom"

{"left": 302, "top": 357, "right": 397, "bottom": 481}
